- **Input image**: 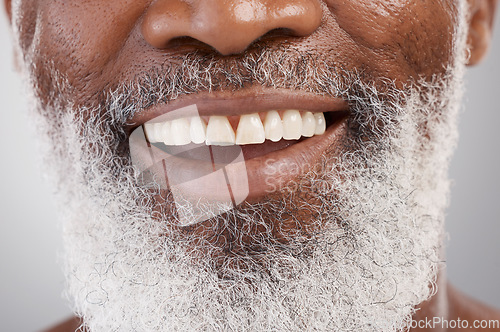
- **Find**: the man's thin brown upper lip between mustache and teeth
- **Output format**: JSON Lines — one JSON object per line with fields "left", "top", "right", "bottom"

{"left": 125, "top": 88, "right": 349, "bottom": 133}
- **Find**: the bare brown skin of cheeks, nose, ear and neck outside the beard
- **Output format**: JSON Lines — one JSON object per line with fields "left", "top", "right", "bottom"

{"left": 4, "top": 0, "right": 500, "bottom": 332}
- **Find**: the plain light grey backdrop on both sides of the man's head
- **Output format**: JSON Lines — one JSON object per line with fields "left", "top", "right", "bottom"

{"left": 0, "top": 9, "right": 500, "bottom": 332}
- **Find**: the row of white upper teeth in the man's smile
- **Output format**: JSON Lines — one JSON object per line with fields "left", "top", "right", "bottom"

{"left": 144, "top": 110, "right": 326, "bottom": 145}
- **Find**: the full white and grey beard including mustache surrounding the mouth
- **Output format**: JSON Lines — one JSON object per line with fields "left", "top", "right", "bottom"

{"left": 23, "top": 3, "right": 465, "bottom": 331}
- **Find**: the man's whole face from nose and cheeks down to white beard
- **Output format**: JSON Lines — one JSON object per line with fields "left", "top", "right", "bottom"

{"left": 5, "top": 0, "right": 476, "bottom": 331}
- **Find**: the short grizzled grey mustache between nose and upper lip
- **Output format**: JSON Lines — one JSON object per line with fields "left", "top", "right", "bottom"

{"left": 102, "top": 45, "right": 398, "bottom": 125}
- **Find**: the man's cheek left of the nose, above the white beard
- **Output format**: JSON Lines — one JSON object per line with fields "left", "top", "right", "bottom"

{"left": 19, "top": 0, "right": 149, "bottom": 102}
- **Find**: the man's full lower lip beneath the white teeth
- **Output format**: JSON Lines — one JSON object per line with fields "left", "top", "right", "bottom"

{"left": 129, "top": 112, "right": 347, "bottom": 213}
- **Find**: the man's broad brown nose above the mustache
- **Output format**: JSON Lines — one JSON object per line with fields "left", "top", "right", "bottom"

{"left": 141, "top": 0, "right": 322, "bottom": 55}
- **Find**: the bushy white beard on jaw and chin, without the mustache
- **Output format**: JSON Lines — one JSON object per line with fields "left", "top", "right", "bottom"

{"left": 23, "top": 3, "right": 465, "bottom": 331}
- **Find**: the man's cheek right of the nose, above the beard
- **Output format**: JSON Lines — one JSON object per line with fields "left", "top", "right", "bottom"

{"left": 326, "top": 0, "right": 455, "bottom": 80}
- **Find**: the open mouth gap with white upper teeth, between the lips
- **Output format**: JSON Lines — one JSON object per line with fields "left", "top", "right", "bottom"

{"left": 143, "top": 109, "right": 339, "bottom": 160}
